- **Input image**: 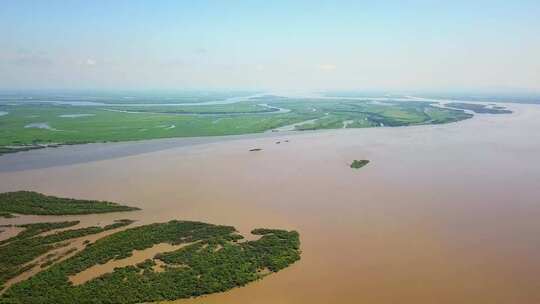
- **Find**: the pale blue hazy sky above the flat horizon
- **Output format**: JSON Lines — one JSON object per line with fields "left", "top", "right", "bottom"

{"left": 0, "top": 0, "right": 540, "bottom": 92}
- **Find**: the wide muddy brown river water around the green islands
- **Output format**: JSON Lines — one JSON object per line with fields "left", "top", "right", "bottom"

{"left": 0, "top": 105, "right": 540, "bottom": 304}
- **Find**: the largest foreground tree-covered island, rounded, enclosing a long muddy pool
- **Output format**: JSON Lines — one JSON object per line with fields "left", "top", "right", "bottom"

{"left": 0, "top": 221, "right": 300, "bottom": 304}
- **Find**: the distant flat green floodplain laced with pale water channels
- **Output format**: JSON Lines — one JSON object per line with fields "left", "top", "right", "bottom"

{"left": 0, "top": 92, "right": 472, "bottom": 153}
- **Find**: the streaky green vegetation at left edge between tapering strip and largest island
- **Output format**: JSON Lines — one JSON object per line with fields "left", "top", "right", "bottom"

{"left": 0, "top": 220, "right": 133, "bottom": 288}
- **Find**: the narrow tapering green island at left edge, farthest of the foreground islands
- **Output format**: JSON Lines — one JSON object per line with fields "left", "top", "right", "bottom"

{"left": 0, "top": 191, "right": 139, "bottom": 217}
